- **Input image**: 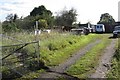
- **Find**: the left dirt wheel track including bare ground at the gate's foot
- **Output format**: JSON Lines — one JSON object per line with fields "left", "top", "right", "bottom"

{"left": 37, "top": 40, "right": 101, "bottom": 79}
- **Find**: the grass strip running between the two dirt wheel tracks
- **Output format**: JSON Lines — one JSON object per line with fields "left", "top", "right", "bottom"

{"left": 66, "top": 35, "right": 110, "bottom": 78}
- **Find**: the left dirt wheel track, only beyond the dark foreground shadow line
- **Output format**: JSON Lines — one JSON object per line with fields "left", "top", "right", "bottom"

{"left": 51, "top": 40, "right": 101, "bottom": 73}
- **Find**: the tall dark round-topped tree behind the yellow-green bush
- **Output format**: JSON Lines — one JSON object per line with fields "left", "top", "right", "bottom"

{"left": 30, "top": 5, "right": 54, "bottom": 28}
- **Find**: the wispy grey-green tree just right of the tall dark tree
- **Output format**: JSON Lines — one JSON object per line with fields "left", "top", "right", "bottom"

{"left": 55, "top": 8, "right": 77, "bottom": 29}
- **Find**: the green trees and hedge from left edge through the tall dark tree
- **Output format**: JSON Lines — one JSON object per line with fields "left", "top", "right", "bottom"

{"left": 2, "top": 5, "right": 54, "bottom": 32}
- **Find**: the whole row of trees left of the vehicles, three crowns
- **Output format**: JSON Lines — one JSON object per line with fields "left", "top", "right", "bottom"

{"left": 2, "top": 5, "right": 77, "bottom": 32}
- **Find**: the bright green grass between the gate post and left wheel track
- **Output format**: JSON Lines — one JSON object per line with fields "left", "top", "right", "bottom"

{"left": 40, "top": 34, "right": 100, "bottom": 66}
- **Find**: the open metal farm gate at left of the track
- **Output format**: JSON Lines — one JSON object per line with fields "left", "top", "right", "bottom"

{"left": 0, "top": 35, "right": 40, "bottom": 78}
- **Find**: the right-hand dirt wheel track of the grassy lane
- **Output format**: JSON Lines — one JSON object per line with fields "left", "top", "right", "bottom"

{"left": 90, "top": 39, "right": 117, "bottom": 78}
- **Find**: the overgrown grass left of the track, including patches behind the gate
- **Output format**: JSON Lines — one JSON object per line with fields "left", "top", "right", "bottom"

{"left": 2, "top": 32, "right": 103, "bottom": 78}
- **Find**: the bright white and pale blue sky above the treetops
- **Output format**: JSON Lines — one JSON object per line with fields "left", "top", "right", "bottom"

{"left": 0, "top": 0, "right": 120, "bottom": 24}
